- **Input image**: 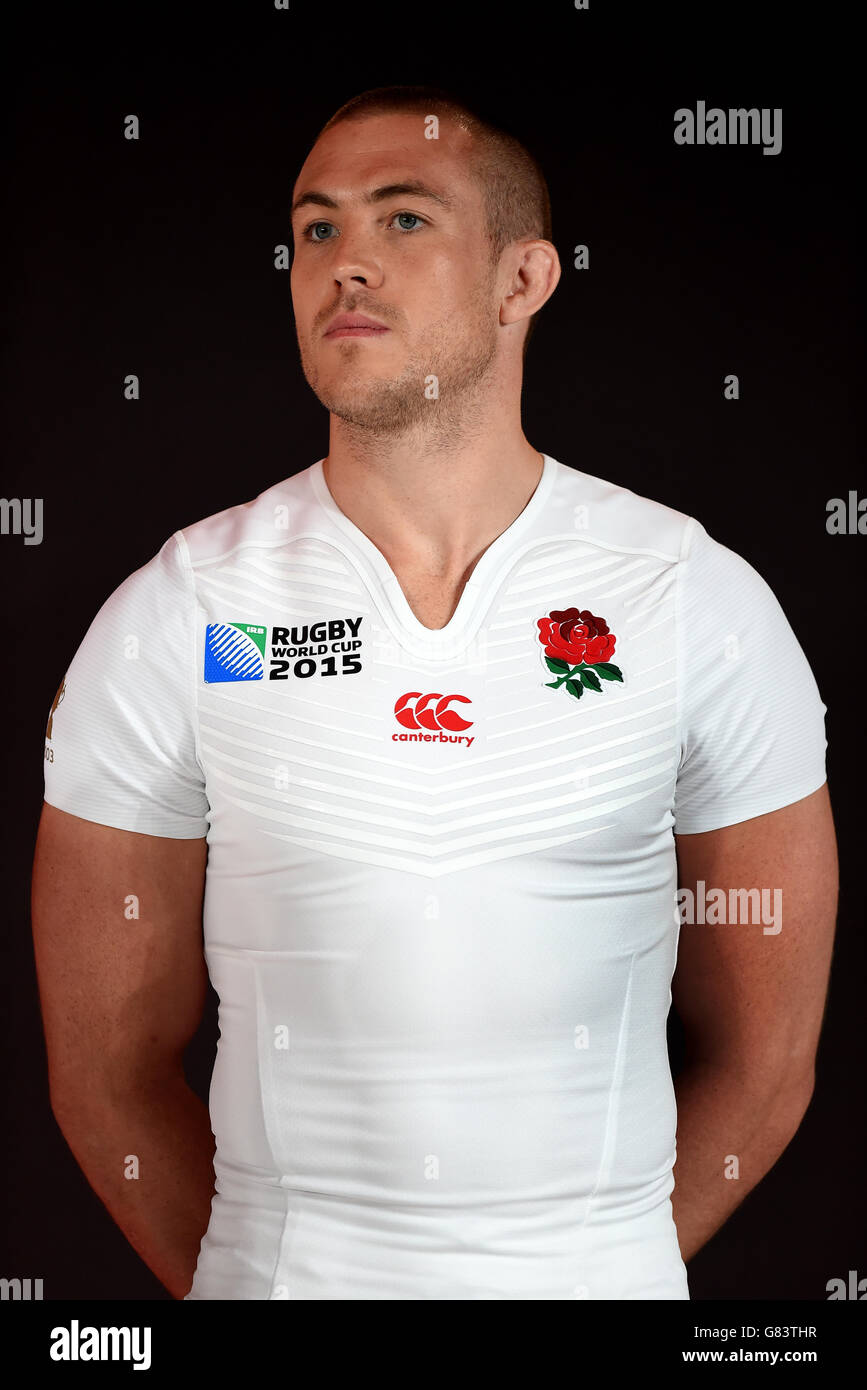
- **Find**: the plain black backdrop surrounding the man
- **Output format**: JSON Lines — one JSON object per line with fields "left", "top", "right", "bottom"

{"left": 0, "top": 0, "right": 867, "bottom": 1300}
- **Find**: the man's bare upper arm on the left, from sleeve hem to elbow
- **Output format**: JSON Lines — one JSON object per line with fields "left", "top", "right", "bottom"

{"left": 32, "top": 803, "right": 207, "bottom": 1101}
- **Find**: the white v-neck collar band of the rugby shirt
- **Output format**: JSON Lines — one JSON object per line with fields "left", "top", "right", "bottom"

{"left": 310, "top": 453, "right": 559, "bottom": 656}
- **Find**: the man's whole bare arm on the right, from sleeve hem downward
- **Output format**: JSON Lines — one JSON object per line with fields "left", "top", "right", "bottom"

{"left": 671, "top": 784, "right": 838, "bottom": 1259}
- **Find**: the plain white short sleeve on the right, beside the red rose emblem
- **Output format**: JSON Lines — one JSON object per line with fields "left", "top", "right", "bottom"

{"left": 674, "top": 518, "right": 827, "bottom": 835}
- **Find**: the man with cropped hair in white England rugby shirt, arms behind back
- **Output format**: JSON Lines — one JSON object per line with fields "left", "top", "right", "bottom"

{"left": 33, "top": 89, "right": 835, "bottom": 1300}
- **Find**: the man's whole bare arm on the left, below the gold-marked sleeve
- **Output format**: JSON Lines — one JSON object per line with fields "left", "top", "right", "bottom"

{"left": 32, "top": 803, "right": 214, "bottom": 1298}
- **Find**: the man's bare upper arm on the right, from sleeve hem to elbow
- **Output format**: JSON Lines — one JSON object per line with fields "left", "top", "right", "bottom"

{"left": 672, "top": 784, "right": 838, "bottom": 1076}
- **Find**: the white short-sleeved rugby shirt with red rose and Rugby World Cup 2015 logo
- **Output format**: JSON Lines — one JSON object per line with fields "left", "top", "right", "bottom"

{"left": 44, "top": 456, "right": 825, "bottom": 1300}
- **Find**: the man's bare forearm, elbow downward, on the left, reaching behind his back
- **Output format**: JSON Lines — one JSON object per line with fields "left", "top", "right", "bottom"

{"left": 54, "top": 1076, "right": 214, "bottom": 1298}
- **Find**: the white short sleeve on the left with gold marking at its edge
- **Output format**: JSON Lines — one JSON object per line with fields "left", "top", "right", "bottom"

{"left": 44, "top": 534, "right": 208, "bottom": 840}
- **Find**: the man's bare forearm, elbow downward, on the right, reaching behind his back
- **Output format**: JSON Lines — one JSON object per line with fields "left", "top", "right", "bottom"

{"left": 671, "top": 1062, "right": 811, "bottom": 1261}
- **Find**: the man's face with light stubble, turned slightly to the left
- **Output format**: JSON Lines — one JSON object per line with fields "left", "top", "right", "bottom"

{"left": 292, "top": 114, "right": 500, "bottom": 434}
